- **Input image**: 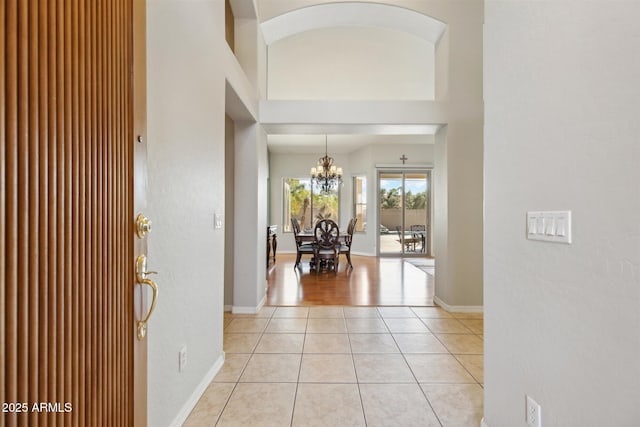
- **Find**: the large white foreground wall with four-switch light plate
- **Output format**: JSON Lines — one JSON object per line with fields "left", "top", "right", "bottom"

{"left": 484, "top": 0, "right": 640, "bottom": 427}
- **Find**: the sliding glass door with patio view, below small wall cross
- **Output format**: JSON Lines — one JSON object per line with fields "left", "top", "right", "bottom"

{"left": 378, "top": 169, "right": 431, "bottom": 256}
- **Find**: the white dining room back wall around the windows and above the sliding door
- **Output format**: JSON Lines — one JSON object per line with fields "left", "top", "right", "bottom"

{"left": 269, "top": 141, "right": 434, "bottom": 256}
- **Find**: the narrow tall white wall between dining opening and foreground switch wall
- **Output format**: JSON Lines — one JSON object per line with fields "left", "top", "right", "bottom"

{"left": 436, "top": 0, "right": 483, "bottom": 310}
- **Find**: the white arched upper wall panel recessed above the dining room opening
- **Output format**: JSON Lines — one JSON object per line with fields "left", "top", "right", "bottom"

{"left": 268, "top": 27, "right": 434, "bottom": 100}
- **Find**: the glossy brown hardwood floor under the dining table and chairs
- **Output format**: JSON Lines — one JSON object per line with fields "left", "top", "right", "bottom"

{"left": 267, "top": 254, "right": 434, "bottom": 306}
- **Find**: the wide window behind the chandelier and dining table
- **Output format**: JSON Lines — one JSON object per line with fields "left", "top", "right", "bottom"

{"left": 282, "top": 178, "right": 340, "bottom": 232}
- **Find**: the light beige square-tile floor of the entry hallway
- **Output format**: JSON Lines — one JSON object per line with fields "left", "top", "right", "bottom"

{"left": 184, "top": 307, "right": 483, "bottom": 427}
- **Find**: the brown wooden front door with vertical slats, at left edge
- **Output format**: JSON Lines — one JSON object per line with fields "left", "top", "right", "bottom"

{"left": 0, "top": 0, "right": 146, "bottom": 426}
